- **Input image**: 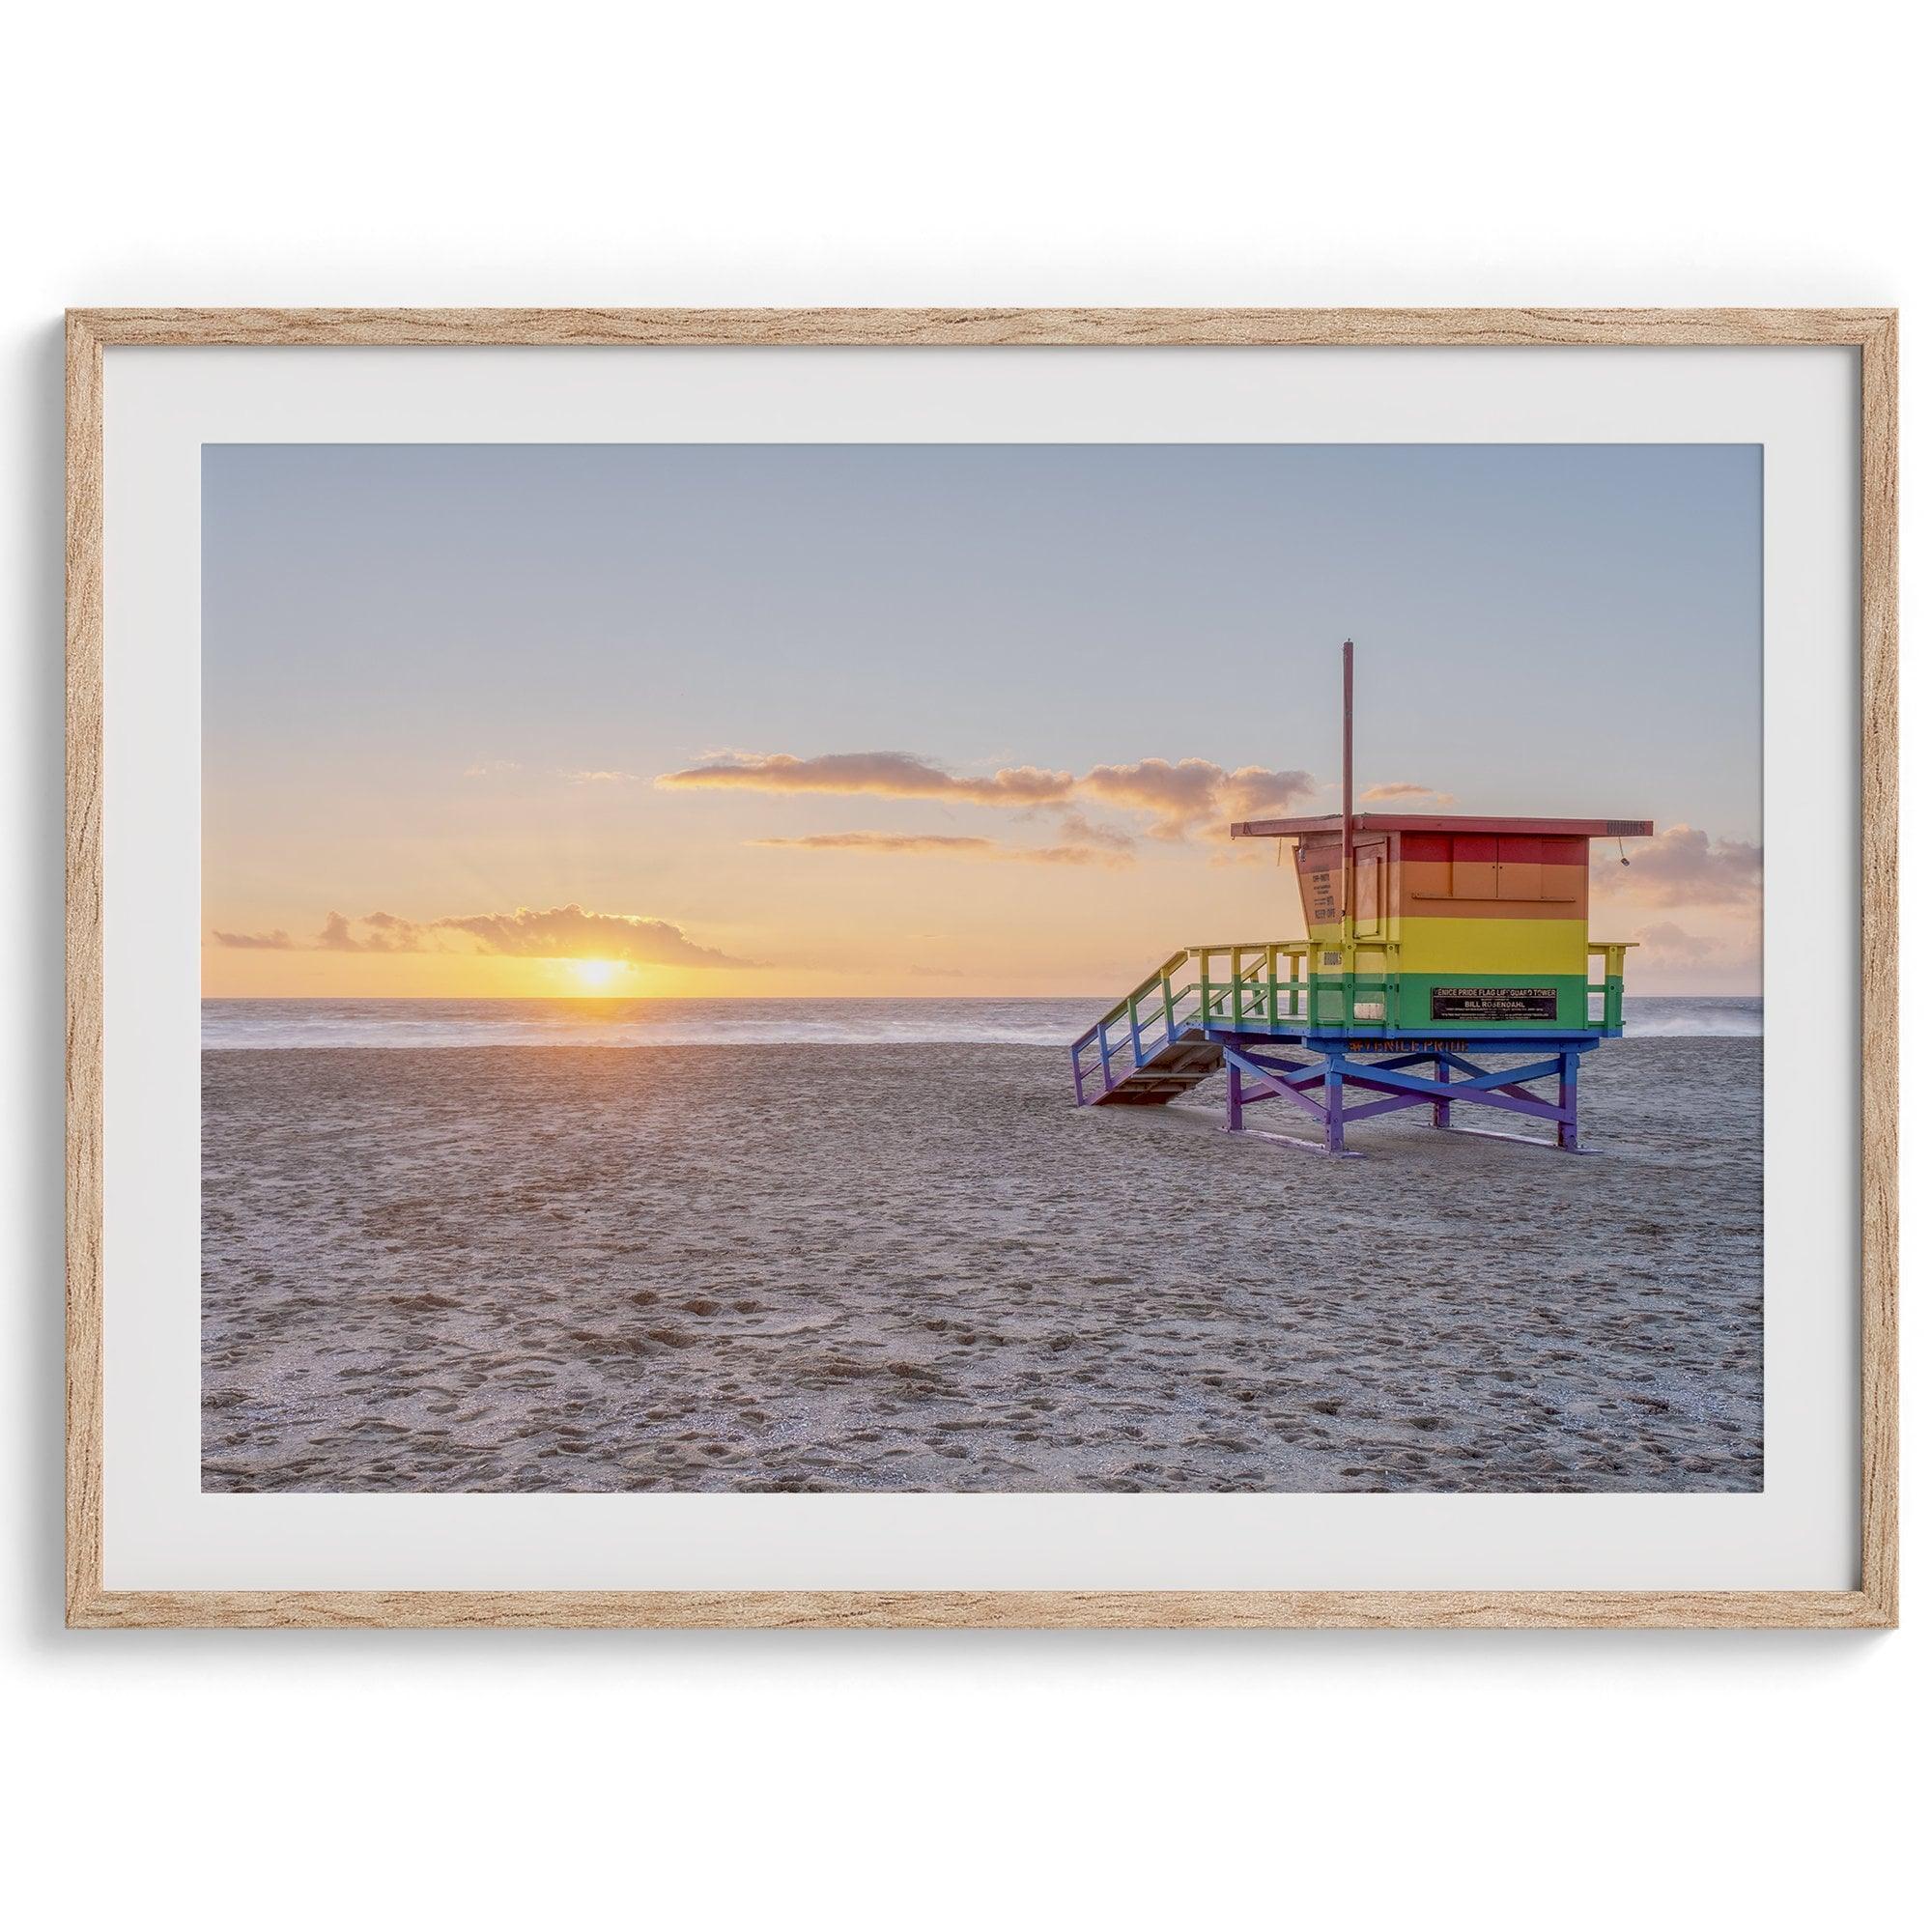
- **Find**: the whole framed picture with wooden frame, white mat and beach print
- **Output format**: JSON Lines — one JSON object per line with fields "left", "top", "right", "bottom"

{"left": 68, "top": 309, "right": 1897, "bottom": 1627}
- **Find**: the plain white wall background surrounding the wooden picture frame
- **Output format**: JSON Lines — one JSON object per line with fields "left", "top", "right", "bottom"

{"left": 0, "top": 0, "right": 1932, "bottom": 1926}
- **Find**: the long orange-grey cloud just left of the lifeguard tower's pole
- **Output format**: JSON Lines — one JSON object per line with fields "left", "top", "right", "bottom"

{"left": 657, "top": 752, "right": 1316, "bottom": 842}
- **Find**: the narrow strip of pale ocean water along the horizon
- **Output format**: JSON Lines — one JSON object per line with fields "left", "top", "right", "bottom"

{"left": 201, "top": 997, "right": 1764, "bottom": 1049}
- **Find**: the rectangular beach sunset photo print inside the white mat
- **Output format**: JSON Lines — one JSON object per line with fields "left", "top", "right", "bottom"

{"left": 201, "top": 444, "right": 1764, "bottom": 1493}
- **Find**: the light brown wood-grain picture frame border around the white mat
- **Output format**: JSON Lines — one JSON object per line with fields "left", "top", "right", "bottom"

{"left": 66, "top": 309, "right": 1899, "bottom": 1629}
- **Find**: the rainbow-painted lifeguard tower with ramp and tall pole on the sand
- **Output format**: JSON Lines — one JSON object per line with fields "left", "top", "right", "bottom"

{"left": 1072, "top": 643, "right": 1652, "bottom": 1155}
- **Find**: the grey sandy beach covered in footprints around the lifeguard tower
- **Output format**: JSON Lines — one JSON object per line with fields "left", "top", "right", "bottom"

{"left": 203, "top": 1037, "right": 1762, "bottom": 1492}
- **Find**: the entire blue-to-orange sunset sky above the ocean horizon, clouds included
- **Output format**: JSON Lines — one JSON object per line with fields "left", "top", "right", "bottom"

{"left": 203, "top": 444, "right": 1760, "bottom": 997}
